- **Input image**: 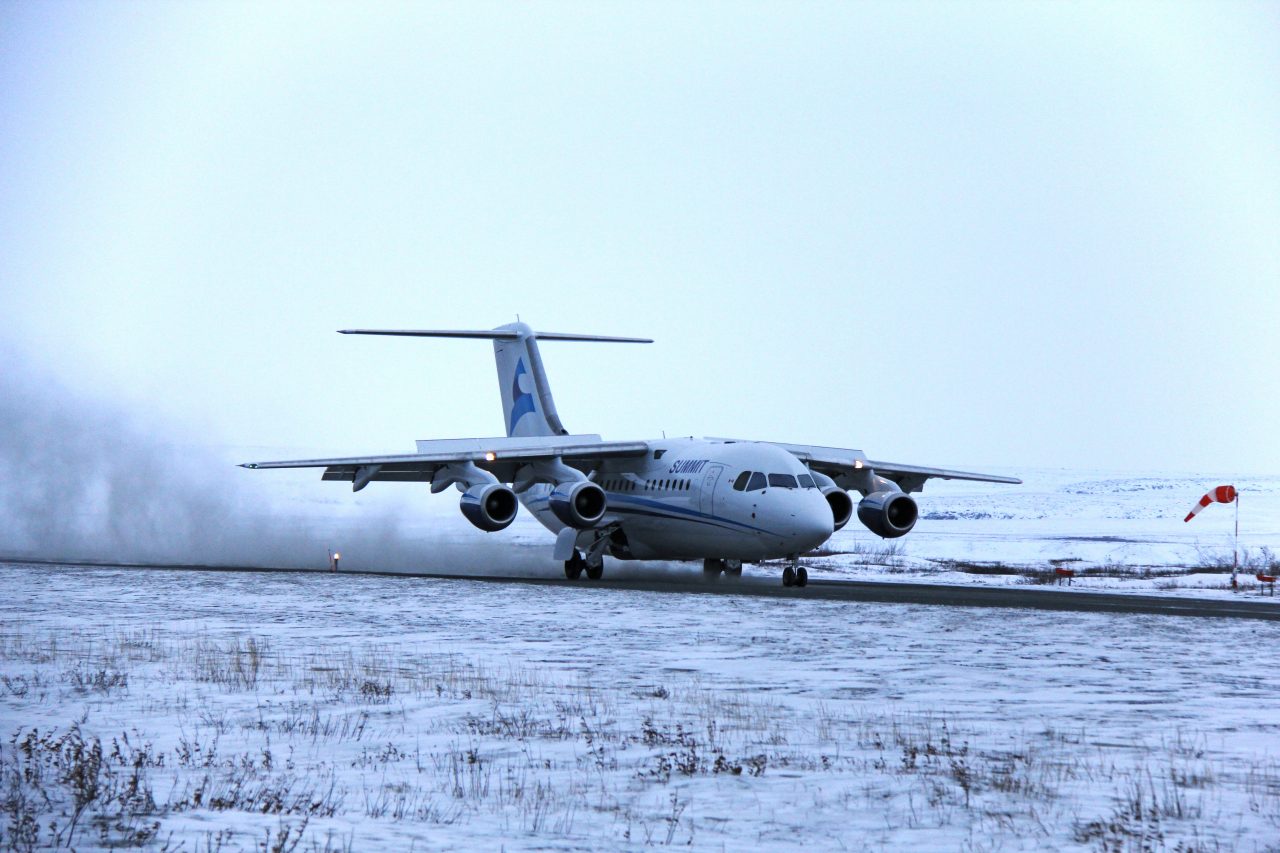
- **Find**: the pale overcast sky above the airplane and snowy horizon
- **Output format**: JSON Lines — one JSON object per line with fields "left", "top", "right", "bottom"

{"left": 0, "top": 1, "right": 1280, "bottom": 473}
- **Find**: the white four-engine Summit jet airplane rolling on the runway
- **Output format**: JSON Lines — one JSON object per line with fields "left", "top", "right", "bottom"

{"left": 242, "top": 323, "right": 1021, "bottom": 587}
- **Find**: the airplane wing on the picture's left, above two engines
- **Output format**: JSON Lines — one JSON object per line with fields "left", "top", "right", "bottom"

{"left": 241, "top": 435, "right": 649, "bottom": 492}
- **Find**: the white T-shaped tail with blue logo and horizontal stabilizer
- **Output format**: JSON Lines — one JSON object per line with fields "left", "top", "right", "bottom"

{"left": 342, "top": 323, "right": 653, "bottom": 435}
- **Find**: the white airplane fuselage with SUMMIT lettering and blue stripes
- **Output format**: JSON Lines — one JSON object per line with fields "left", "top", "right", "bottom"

{"left": 520, "top": 438, "right": 833, "bottom": 561}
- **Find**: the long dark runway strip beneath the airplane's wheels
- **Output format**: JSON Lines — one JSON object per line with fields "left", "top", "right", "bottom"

{"left": 12, "top": 550, "right": 1280, "bottom": 621}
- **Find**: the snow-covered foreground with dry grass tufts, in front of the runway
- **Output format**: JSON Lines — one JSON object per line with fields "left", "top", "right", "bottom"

{"left": 0, "top": 565, "right": 1280, "bottom": 850}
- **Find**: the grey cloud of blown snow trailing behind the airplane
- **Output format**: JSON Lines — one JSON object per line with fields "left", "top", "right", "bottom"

{"left": 0, "top": 348, "right": 553, "bottom": 574}
